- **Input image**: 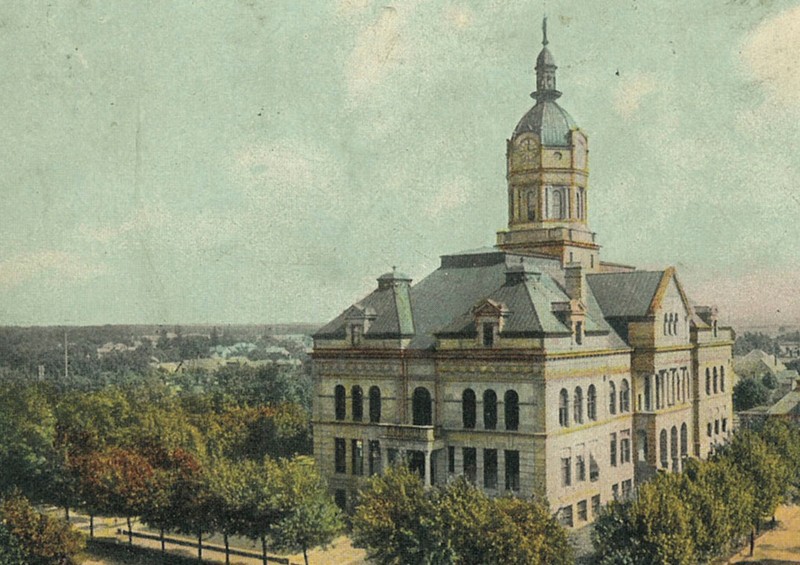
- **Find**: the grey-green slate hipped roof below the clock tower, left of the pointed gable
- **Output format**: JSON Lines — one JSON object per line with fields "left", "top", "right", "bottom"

{"left": 315, "top": 248, "right": 624, "bottom": 349}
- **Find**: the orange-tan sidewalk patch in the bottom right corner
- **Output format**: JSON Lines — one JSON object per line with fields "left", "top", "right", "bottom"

{"left": 728, "top": 506, "right": 800, "bottom": 565}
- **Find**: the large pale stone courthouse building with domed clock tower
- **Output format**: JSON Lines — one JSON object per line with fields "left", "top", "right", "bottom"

{"left": 313, "top": 20, "right": 733, "bottom": 526}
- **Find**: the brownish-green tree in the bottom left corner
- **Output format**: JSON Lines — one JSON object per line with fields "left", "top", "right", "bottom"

{"left": 0, "top": 495, "right": 85, "bottom": 565}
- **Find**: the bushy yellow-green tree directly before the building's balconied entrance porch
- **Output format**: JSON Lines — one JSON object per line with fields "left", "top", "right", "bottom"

{"left": 352, "top": 465, "right": 439, "bottom": 565}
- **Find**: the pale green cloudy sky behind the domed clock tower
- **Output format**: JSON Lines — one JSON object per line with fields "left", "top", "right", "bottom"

{"left": 0, "top": 0, "right": 800, "bottom": 325}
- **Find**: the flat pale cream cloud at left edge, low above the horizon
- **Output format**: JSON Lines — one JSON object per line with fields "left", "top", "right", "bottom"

{"left": 0, "top": 251, "right": 106, "bottom": 288}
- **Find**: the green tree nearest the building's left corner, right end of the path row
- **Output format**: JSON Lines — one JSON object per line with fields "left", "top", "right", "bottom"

{"left": 273, "top": 457, "right": 343, "bottom": 565}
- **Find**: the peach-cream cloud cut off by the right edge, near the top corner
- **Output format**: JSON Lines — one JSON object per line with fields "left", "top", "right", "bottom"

{"left": 741, "top": 6, "right": 800, "bottom": 106}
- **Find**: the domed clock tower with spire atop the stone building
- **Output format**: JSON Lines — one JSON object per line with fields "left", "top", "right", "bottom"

{"left": 497, "top": 18, "right": 600, "bottom": 271}
